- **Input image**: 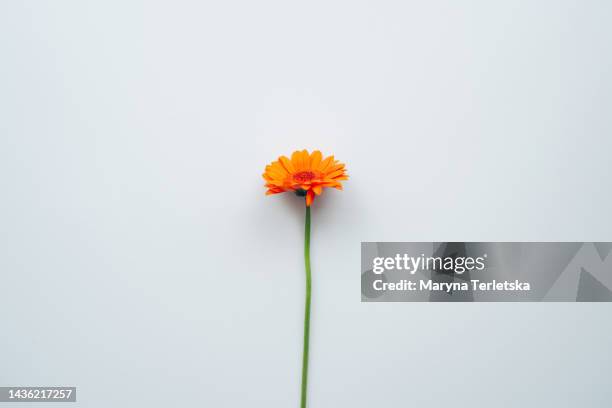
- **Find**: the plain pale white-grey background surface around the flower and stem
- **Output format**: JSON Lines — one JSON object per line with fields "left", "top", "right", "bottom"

{"left": 0, "top": 0, "right": 612, "bottom": 408}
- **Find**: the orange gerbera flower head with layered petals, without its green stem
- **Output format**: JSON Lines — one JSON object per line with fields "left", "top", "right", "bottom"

{"left": 263, "top": 150, "right": 348, "bottom": 206}
